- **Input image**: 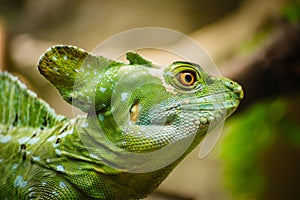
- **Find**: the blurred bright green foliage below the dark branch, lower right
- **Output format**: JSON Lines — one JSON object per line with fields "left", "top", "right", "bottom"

{"left": 221, "top": 100, "right": 300, "bottom": 200}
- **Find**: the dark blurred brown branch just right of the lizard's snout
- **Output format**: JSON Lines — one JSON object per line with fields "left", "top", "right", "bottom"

{"left": 222, "top": 23, "right": 300, "bottom": 109}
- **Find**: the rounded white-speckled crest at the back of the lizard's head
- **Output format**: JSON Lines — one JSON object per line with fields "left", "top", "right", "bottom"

{"left": 38, "top": 46, "right": 116, "bottom": 112}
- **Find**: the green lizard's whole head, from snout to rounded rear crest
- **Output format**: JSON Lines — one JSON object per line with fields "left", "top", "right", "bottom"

{"left": 38, "top": 46, "right": 243, "bottom": 171}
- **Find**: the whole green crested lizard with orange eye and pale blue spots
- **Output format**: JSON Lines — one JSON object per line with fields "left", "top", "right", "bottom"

{"left": 0, "top": 46, "right": 243, "bottom": 200}
